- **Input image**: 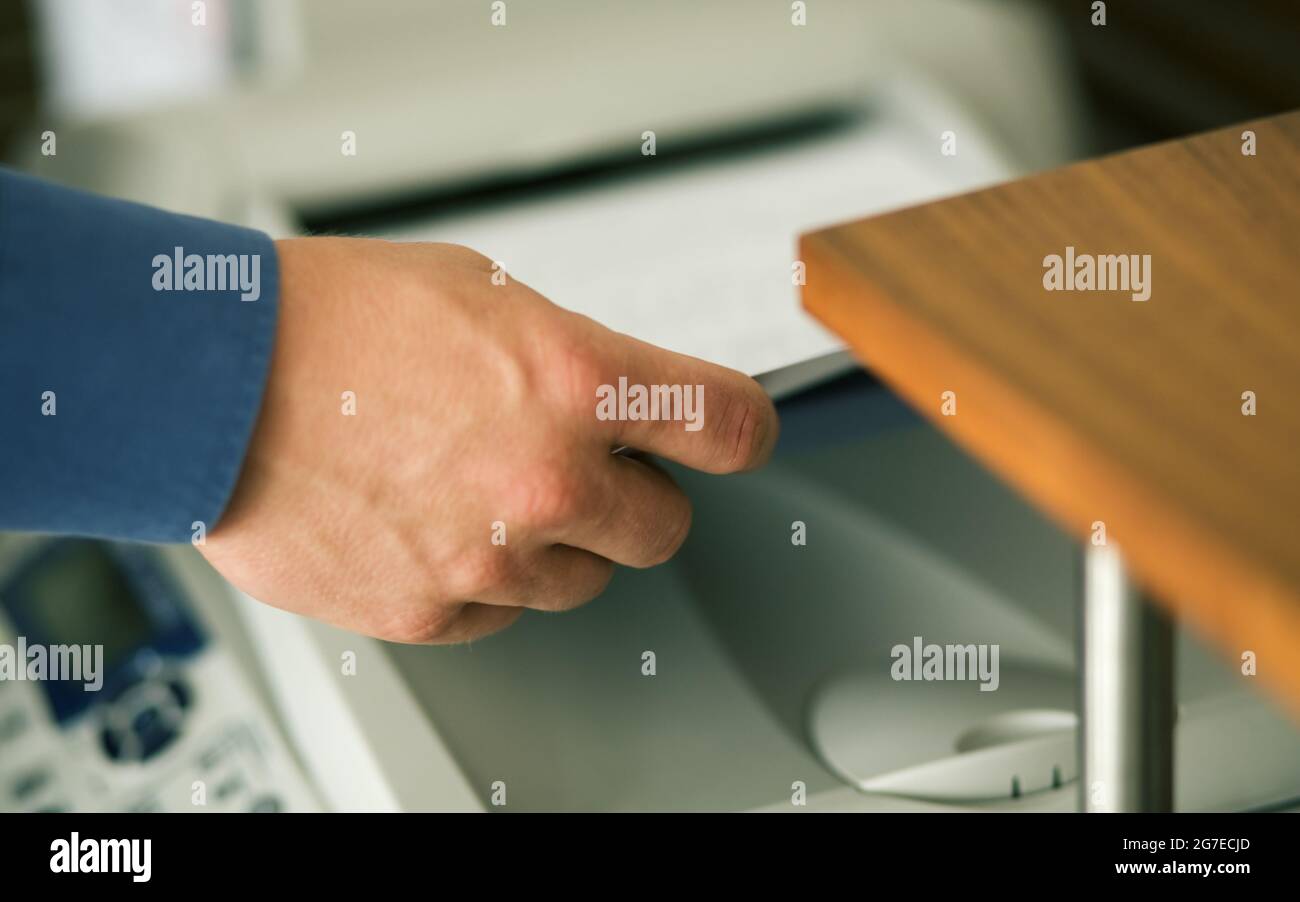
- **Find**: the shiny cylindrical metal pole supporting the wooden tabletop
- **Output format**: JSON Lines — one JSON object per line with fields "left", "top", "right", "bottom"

{"left": 1079, "top": 545, "right": 1175, "bottom": 811}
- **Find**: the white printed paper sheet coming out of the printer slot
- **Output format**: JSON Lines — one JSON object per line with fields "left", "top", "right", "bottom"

{"left": 381, "top": 94, "right": 1008, "bottom": 374}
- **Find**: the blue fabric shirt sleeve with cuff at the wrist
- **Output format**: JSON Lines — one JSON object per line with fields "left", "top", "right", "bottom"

{"left": 0, "top": 169, "right": 280, "bottom": 542}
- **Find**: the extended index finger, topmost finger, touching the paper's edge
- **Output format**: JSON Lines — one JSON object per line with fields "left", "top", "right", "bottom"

{"left": 597, "top": 335, "right": 780, "bottom": 473}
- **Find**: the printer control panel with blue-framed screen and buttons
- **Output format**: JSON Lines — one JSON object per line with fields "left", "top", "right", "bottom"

{"left": 0, "top": 537, "right": 317, "bottom": 812}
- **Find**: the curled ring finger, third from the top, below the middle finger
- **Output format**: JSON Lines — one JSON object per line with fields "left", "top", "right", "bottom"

{"left": 476, "top": 545, "right": 614, "bottom": 611}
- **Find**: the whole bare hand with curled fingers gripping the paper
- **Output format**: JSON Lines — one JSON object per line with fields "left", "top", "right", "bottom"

{"left": 202, "top": 238, "right": 777, "bottom": 643}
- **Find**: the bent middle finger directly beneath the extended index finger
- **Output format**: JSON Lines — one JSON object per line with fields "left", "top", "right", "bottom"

{"left": 559, "top": 455, "right": 690, "bottom": 567}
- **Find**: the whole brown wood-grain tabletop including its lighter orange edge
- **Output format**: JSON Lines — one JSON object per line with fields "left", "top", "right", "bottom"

{"left": 801, "top": 112, "right": 1300, "bottom": 712}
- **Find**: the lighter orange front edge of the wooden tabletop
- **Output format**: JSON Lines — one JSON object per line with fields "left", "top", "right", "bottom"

{"left": 800, "top": 229, "right": 1300, "bottom": 716}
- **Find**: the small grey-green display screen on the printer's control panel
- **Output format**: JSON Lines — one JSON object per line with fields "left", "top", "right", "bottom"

{"left": 10, "top": 542, "right": 152, "bottom": 668}
